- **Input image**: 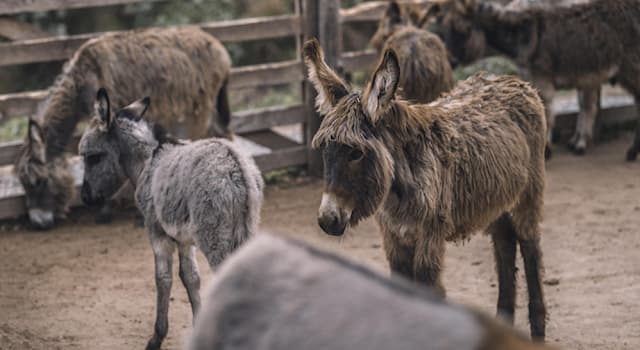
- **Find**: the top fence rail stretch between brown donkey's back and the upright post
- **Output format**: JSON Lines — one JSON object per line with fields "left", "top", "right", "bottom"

{"left": 201, "top": 15, "right": 301, "bottom": 43}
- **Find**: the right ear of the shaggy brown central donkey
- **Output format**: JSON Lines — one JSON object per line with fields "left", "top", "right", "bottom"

{"left": 362, "top": 49, "right": 400, "bottom": 125}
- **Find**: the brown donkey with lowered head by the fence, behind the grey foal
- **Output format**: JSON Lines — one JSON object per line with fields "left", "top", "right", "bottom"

{"left": 15, "top": 27, "right": 231, "bottom": 229}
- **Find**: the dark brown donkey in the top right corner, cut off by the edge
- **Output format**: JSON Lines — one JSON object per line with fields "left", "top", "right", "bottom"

{"left": 428, "top": 0, "right": 640, "bottom": 161}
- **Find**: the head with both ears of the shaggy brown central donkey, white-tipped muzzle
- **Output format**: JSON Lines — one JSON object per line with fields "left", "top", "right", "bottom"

{"left": 304, "top": 39, "right": 400, "bottom": 235}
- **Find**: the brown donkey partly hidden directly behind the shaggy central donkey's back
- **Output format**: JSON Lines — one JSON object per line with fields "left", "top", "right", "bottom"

{"left": 371, "top": 1, "right": 454, "bottom": 103}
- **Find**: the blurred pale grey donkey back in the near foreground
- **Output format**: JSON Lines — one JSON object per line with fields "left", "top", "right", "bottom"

{"left": 188, "top": 235, "right": 547, "bottom": 350}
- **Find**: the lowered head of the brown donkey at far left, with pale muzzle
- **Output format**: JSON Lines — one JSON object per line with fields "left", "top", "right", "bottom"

{"left": 14, "top": 119, "right": 74, "bottom": 229}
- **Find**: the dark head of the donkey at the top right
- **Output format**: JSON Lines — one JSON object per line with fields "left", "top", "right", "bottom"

{"left": 420, "top": 0, "right": 487, "bottom": 64}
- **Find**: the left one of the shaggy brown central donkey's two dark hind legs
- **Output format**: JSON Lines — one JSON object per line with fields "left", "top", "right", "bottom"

{"left": 487, "top": 213, "right": 517, "bottom": 324}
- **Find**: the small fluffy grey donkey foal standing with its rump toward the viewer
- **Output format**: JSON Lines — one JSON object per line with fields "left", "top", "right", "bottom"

{"left": 79, "top": 89, "right": 263, "bottom": 349}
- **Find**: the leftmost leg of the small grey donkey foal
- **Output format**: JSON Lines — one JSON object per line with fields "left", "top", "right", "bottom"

{"left": 146, "top": 230, "right": 175, "bottom": 350}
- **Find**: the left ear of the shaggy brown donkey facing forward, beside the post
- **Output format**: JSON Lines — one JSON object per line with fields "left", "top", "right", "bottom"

{"left": 303, "top": 38, "right": 349, "bottom": 115}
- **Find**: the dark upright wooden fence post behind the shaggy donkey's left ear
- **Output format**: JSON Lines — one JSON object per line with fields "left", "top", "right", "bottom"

{"left": 303, "top": 0, "right": 342, "bottom": 176}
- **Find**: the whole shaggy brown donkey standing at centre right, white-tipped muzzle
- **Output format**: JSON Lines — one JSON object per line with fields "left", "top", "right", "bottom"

{"left": 304, "top": 40, "right": 546, "bottom": 339}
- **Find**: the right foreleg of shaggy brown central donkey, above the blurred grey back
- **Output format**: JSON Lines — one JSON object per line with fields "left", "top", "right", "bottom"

{"left": 413, "top": 236, "right": 446, "bottom": 298}
